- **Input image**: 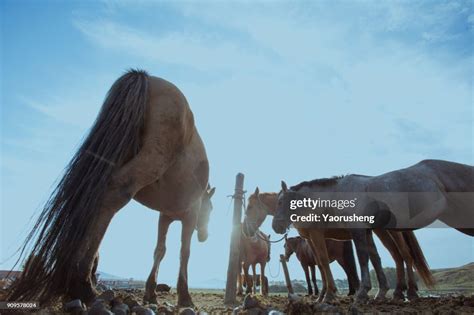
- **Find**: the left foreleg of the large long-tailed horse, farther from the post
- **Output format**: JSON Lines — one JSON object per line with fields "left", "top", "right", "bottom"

{"left": 144, "top": 214, "right": 173, "bottom": 304}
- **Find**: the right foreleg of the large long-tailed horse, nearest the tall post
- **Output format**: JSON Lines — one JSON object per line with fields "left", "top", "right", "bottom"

{"left": 176, "top": 208, "right": 197, "bottom": 306}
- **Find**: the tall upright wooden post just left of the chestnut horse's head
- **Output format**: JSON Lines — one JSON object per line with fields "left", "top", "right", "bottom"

{"left": 224, "top": 173, "right": 244, "bottom": 305}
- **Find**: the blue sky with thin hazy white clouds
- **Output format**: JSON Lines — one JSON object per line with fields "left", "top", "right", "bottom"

{"left": 0, "top": 1, "right": 474, "bottom": 286}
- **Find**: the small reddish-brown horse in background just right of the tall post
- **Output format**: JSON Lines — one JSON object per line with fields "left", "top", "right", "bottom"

{"left": 237, "top": 226, "right": 270, "bottom": 296}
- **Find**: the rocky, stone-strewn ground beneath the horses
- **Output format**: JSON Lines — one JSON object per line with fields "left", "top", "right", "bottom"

{"left": 0, "top": 290, "right": 474, "bottom": 315}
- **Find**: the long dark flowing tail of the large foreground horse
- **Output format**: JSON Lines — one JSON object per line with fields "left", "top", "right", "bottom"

{"left": 7, "top": 70, "right": 148, "bottom": 303}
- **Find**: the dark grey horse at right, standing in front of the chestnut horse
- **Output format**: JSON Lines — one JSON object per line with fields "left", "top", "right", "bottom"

{"left": 272, "top": 160, "right": 474, "bottom": 301}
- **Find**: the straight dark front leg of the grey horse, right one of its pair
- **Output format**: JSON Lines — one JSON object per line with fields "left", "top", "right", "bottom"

{"left": 351, "top": 229, "right": 372, "bottom": 303}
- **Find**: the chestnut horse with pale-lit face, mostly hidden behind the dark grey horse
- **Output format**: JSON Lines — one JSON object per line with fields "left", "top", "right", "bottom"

{"left": 244, "top": 187, "right": 434, "bottom": 300}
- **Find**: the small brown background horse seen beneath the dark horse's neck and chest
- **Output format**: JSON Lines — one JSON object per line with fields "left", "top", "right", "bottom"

{"left": 285, "top": 236, "right": 359, "bottom": 296}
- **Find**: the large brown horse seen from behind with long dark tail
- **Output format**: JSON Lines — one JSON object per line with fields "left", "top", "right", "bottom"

{"left": 8, "top": 70, "right": 209, "bottom": 306}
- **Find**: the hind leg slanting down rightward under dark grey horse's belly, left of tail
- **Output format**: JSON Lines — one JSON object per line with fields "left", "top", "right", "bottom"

{"left": 374, "top": 230, "right": 407, "bottom": 301}
